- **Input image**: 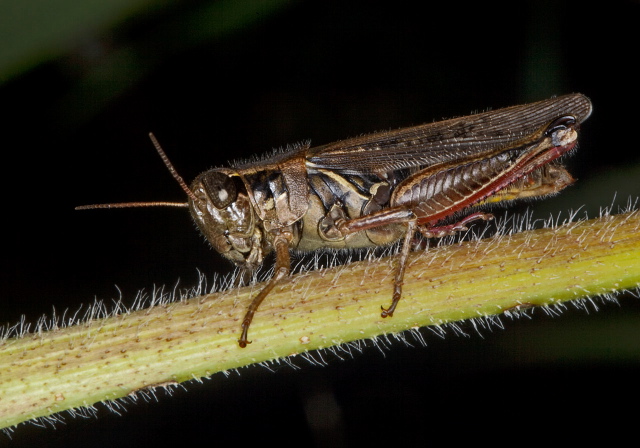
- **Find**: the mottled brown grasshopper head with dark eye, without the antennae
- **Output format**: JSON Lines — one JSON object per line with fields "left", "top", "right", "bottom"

{"left": 189, "top": 168, "right": 266, "bottom": 271}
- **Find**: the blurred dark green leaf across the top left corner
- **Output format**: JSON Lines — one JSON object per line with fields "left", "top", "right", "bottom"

{"left": 0, "top": 0, "right": 290, "bottom": 84}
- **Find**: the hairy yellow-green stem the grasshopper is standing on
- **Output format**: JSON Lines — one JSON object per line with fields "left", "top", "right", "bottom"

{"left": 0, "top": 212, "right": 640, "bottom": 427}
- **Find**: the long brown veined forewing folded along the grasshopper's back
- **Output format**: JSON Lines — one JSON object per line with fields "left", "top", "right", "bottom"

{"left": 307, "top": 94, "right": 591, "bottom": 174}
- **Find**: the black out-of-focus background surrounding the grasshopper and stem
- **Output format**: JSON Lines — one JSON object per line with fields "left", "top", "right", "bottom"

{"left": 0, "top": 0, "right": 640, "bottom": 447}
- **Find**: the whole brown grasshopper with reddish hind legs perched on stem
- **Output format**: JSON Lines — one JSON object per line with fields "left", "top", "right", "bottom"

{"left": 78, "top": 94, "right": 592, "bottom": 347}
